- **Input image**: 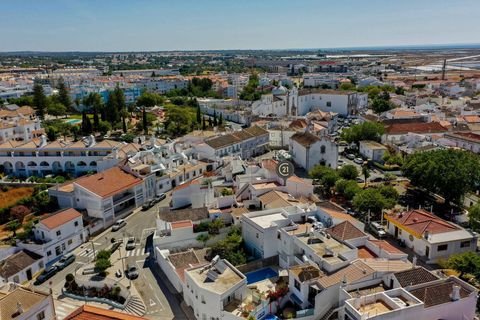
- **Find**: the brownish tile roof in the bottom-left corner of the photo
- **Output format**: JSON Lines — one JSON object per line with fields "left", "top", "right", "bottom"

{"left": 0, "top": 287, "right": 53, "bottom": 320}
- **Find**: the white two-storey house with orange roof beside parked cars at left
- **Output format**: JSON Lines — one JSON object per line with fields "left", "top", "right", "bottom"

{"left": 17, "top": 208, "right": 87, "bottom": 264}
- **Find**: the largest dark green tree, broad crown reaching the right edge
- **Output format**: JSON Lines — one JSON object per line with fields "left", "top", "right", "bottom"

{"left": 402, "top": 149, "right": 480, "bottom": 203}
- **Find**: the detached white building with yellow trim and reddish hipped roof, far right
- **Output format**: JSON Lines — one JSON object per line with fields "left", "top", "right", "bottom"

{"left": 385, "top": 209, "right": 477, "bottom": 263}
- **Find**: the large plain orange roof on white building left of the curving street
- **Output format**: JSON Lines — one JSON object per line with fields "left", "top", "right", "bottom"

{"left": 74, "top": 167, "right": 142, "bottom": 198}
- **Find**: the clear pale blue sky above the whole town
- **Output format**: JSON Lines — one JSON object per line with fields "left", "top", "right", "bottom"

{"left": 0, "top": 0, "right": 480, "bottom": 51}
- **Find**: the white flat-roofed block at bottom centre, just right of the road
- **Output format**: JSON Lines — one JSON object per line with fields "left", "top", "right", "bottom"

{"left": 183, "top": 257, "right": 247, "bottom": 320}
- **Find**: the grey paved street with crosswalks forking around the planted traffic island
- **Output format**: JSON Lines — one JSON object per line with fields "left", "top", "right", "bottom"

{"left": 32, "top": 195, "right": 187, "bottom": 320}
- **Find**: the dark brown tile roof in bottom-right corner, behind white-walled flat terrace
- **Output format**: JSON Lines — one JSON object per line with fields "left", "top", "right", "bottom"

{"left": 410, "top": 279, "right": 472, "bottom": 308}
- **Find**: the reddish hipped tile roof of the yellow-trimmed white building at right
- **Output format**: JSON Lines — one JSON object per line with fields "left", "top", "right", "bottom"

{"left": 385, "top": 209, "right": 459, "bottom": 237}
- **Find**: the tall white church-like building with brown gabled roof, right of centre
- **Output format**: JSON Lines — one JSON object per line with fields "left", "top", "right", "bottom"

{"left": 290, "top": 132, "right": 338, "bottom": 171}
